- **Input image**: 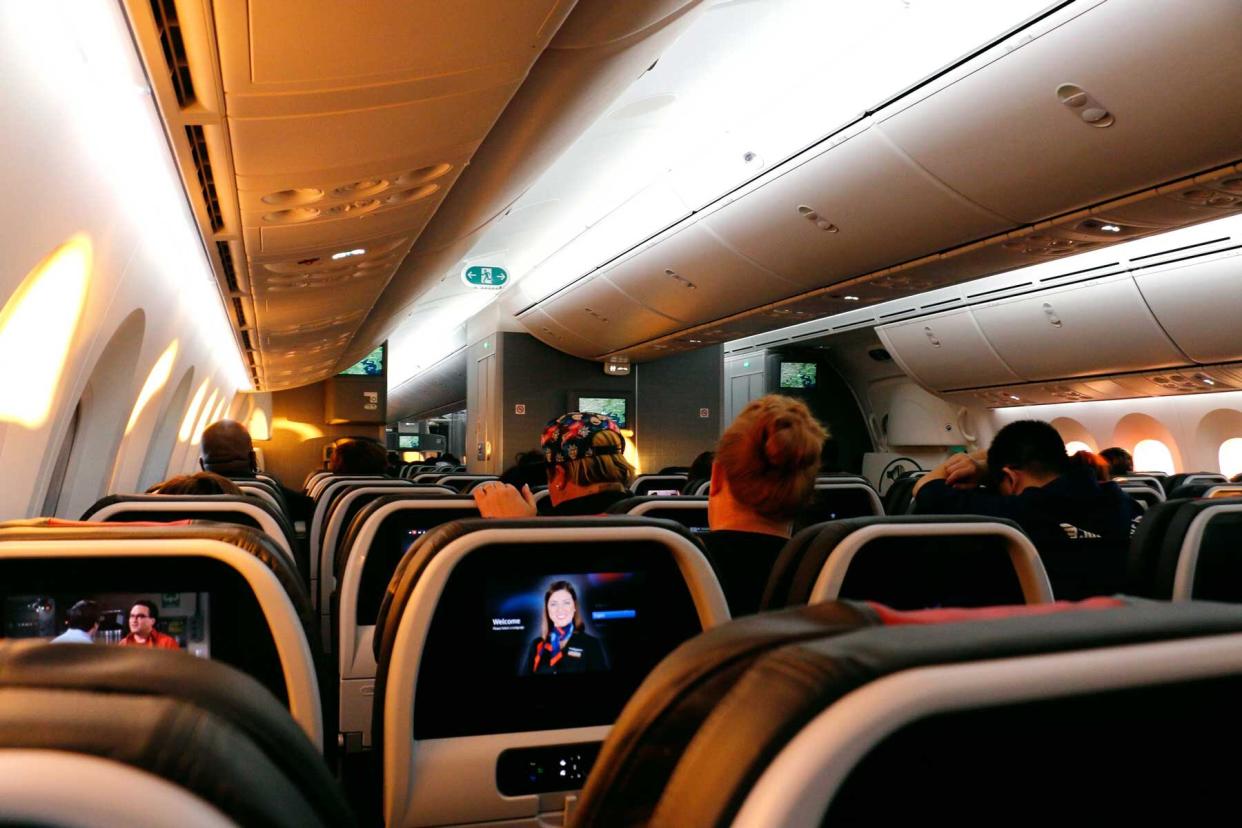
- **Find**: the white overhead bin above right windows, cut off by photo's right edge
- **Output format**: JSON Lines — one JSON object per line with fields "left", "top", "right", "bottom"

{"left": 1134, "top": 251, "right": 1242, "bottom": 362}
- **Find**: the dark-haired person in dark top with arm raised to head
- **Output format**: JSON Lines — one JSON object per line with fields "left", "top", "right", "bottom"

{"left": 914, "top": 420, "right": 1135, "bottom": 600}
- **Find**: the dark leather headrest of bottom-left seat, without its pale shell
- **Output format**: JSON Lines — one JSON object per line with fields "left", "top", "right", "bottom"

{"left": 0, "top": 642, "right": 353, "bottom": 826}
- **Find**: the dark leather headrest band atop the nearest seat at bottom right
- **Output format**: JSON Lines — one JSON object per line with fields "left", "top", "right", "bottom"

{"left": 653, "top": 602, "right": 1242, "bottom": 826}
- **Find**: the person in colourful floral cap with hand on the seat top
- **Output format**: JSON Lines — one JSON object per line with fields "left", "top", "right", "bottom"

{"left": 471, "top": 411, "right": 633, "bottom": 518}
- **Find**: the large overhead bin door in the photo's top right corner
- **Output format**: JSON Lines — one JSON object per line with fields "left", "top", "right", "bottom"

{"left": 878, "top": 0, "right": 1242, "bottom": 223}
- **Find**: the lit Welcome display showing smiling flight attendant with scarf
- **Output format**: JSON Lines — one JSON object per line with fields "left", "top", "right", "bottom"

{"left": 488, "top": 572, "right": 645, "bottom": 675}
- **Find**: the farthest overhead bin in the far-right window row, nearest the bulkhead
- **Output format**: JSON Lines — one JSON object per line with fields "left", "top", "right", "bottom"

{"left": 877, "top": 308, "right": 1022, "bottom": 390}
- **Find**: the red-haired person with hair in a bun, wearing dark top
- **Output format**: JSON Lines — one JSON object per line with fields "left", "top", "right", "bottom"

{"left": 704, "top": 394, "right": 825, "bottom": 618}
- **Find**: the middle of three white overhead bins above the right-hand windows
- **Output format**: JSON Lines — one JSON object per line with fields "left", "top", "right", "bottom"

{"left": 971, "top": 273, "right": 1187, "bottom": 380}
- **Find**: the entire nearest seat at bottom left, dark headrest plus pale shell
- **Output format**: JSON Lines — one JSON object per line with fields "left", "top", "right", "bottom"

{"left": 0, "top": 642, "right": 354, "bottom": 828}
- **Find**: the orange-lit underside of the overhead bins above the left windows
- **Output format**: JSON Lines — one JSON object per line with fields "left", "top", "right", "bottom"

{"left": 187, "top": 0, "right": 575, "bottom": 389}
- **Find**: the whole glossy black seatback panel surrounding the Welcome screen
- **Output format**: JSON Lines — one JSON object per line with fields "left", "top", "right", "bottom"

{"left": 414, "top": 541, "right": 702, "bottom": 739}
